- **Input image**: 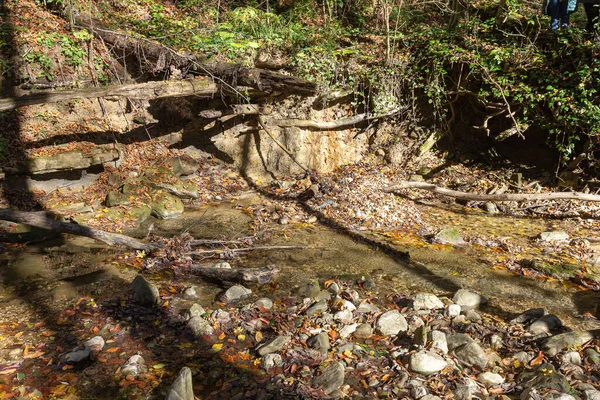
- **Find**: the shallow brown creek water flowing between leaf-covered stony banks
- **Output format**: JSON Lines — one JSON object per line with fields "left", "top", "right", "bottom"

{"left": 0, "top": 196, "right": 600, "bottom": 329}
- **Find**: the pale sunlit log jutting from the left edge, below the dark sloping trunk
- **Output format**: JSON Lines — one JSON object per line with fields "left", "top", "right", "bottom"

{"left": 0, "top": 77, "right": 219, "bottom": 111}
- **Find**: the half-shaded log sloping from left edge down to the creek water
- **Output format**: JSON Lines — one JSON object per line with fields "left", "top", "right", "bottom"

{"left": 0, "top": 209, "right": 157, "bottom": 250}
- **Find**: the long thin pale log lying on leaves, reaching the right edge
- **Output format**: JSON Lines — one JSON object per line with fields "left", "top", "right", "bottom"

{"left": 385, "top": 181, "right": 600, "bottom": 201}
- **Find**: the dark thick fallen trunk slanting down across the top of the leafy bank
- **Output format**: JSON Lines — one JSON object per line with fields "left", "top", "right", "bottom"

{"left": 75, "top": 13, "right": 317, "bottom": 95}
